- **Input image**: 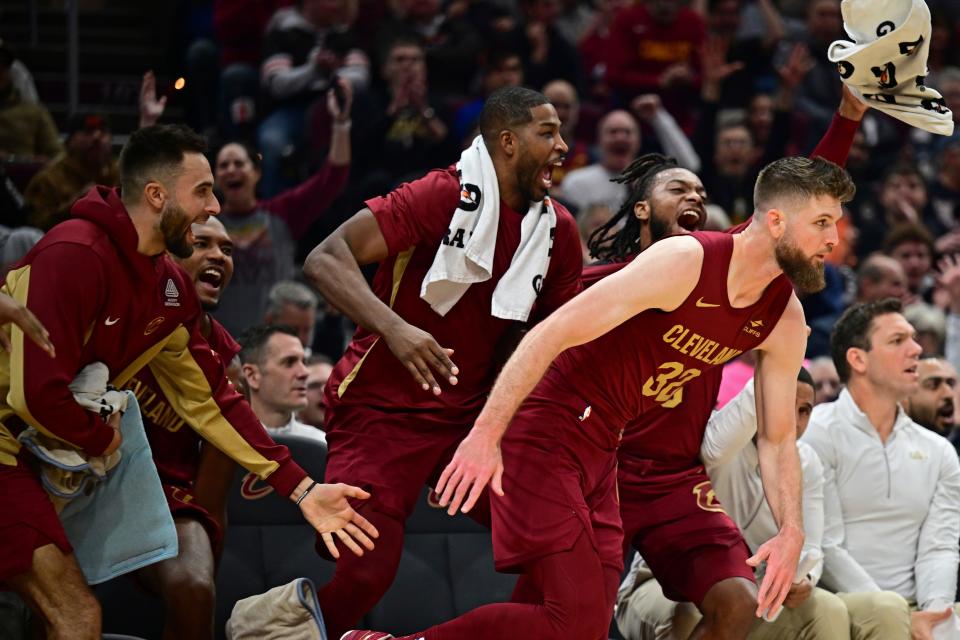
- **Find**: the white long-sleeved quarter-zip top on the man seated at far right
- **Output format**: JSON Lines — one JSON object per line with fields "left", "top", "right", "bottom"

{"left": 803, "top": 389, "right": 960, "bottom": 610}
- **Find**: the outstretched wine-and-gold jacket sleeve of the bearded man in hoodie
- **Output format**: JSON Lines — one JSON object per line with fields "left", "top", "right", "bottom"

{"left": 150, "top": 321, "right": 307, "bottom": 496}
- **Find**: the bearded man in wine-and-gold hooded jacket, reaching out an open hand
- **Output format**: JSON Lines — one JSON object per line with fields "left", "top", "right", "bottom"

{"left": 0, "top": 126, "right": 376, "bottom": 638}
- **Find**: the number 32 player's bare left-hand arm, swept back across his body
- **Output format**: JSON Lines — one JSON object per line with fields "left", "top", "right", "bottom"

{"left": 436, "top": 237, "right": 703, "bottom": 515}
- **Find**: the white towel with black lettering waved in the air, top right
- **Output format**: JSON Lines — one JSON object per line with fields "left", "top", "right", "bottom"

{"left": 827, "top": 0, "right": 953, "bottom": 136}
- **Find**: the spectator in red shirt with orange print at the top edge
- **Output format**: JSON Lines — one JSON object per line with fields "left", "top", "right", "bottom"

{"left": 607, "top": 0, "right": 706, "bottom": 127}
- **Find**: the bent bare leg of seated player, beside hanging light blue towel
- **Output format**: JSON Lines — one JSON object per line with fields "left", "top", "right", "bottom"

{"left": 137, "top": 517, "right": 216, "bottom": 640}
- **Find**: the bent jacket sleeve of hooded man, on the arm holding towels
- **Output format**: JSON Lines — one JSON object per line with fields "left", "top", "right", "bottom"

{"left": 7, "top": 242, "right": 113, "bottom": 455}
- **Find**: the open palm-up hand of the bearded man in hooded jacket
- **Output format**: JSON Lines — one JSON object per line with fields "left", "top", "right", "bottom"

{"left": 290, "top": 476, "right": 380, "bottom": 558}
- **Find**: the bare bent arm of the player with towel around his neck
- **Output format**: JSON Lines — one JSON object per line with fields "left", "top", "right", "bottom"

{"left": 303, "top": 209, "right": 460, "bottom": 395}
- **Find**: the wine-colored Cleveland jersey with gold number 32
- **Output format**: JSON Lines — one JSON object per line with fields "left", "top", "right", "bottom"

{"left": 548, "top": 232, "right": 793, "bottom": 456}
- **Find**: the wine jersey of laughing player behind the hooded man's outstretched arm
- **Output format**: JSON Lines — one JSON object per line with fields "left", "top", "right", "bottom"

{"left": 124, "top": 318, "right": 240, "bottom": 487}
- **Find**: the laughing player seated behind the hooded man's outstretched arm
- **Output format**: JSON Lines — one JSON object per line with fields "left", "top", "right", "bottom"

{"left": 125, "top": 218, "right": 240, "bottom": 638}
